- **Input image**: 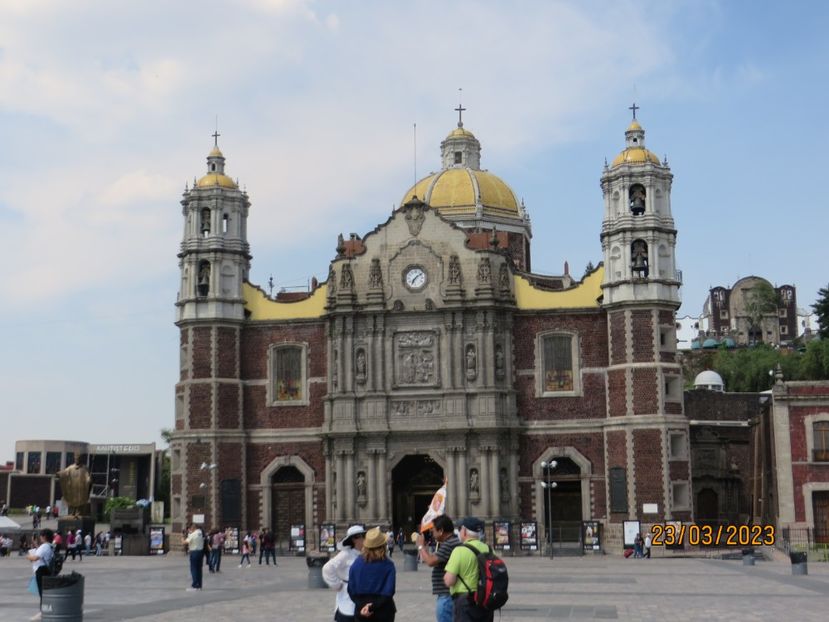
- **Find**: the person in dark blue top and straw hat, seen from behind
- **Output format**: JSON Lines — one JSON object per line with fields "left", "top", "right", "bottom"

{"left": 348, "top": 527, "right": 397, "bottom": 622}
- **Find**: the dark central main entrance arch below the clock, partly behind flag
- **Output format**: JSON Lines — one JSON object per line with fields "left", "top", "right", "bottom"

{"left": 391, "top": 454, "right": 443, "bottom": 537}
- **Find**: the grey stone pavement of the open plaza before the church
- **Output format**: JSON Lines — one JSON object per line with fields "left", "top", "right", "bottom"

{"left": 0, "top": 553, "right": 829, "bottom": 622}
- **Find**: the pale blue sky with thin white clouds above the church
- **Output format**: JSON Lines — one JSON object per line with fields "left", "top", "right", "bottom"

{"left": 0, "top": 0, "right": 829, "bottom": 461}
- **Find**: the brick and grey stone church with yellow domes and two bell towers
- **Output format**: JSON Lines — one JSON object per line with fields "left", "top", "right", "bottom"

{"left": 171, "top": 106, "right": 693, "bottom": 548}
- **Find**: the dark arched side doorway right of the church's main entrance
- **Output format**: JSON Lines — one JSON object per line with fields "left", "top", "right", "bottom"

{"left": 542, "top": 457, "right": 584, "bottom": 543}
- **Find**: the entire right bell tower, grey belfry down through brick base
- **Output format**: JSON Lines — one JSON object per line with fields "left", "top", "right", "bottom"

{"left": 601, "top": 104, "right": 693, "bottom": 531}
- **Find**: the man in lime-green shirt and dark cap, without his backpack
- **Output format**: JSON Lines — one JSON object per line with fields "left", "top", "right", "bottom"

{"left": 443, "top": 516, "right": 494, "bottom": 622}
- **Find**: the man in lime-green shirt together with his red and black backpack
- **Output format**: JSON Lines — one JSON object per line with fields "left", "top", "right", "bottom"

{"left": 443, "top": 516, "right": 508, "bottom": 622}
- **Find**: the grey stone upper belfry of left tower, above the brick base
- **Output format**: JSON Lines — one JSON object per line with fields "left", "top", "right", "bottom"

{"left": 176, "top": 132, "right": 250, "bottom": 322}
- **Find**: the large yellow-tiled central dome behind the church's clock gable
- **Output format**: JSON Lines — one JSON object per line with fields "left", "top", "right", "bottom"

{"left": 400, "top": 168, "right": 521, "bottom": 218}
